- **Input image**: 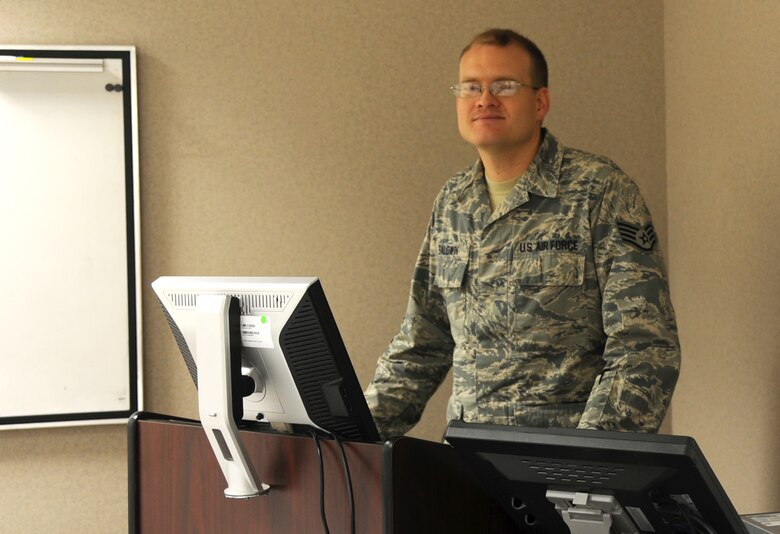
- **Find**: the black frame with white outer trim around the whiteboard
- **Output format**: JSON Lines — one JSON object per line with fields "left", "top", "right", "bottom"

{"left": 0, "top": 45, "right": 143, "bottom": 430}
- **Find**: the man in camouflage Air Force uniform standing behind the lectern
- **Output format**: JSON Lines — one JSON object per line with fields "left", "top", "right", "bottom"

{"left": 366, "top": 30, "right": 680, "bottom": 444}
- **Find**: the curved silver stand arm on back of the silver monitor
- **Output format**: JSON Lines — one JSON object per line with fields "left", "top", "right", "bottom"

{"left": 194, "top": 295, "right": 270, "bottom": 499}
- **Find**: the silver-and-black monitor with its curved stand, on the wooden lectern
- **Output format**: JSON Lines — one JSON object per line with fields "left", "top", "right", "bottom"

{"left": 152, "top": 276, "right": 379, "bottom": 498}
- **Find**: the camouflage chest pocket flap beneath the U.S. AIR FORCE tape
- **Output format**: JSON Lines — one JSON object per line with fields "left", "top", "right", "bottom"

{"left": 512, "top": 252, "right": 585, "bottom": 286}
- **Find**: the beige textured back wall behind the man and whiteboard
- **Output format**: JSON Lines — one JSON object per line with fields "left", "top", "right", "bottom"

{"left": 0, "top": 0, "right": 780, "bottom": 533}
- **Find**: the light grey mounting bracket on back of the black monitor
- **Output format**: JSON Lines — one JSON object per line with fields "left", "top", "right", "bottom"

{"left": 546, "top": 490, "right": 639, "bottom": 534}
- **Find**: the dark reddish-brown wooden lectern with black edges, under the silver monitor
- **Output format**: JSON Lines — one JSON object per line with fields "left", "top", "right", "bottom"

{"left": 128, "top": 413, "right": 518, "bottom": 534}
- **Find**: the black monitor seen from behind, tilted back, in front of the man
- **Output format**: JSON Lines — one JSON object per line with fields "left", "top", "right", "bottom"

{"left": 445, "top": 421, "right": 746, "bottom": 534}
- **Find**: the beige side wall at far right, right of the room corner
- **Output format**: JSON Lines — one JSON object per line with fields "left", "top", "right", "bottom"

{"left": 664, "top": 0, "right": 780, "bottom": 513}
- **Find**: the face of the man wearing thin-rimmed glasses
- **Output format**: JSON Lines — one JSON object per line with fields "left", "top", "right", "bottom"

{"left": 456, "top": 44, "right": 549, "bottom": 154}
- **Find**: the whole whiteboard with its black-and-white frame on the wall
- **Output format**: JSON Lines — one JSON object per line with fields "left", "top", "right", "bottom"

{"left": 0, "top": 46, "right": 142, "bottom": 429}
